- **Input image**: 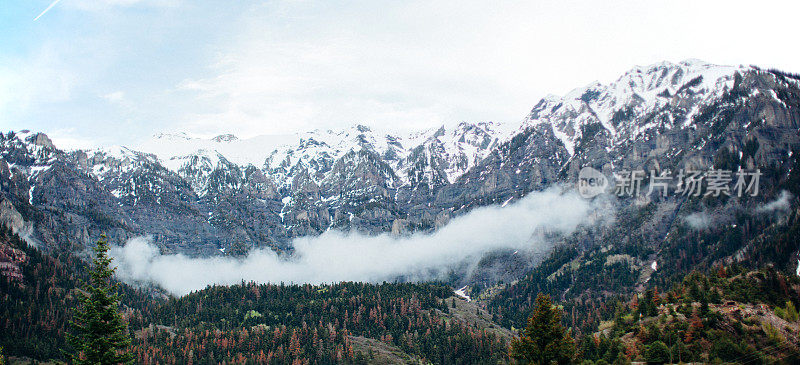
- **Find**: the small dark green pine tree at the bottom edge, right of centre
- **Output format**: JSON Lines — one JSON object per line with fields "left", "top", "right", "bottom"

{"left": 509, "top": 293, "right": 575, "bottom": 364}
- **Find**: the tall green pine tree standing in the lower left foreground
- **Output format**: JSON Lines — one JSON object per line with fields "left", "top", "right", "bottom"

{"left": 68, "top": 235, "right": 133, "bottom": 364}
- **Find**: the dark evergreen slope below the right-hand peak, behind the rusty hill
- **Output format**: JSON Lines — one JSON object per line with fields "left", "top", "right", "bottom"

{"left": 484, "top": 141, "right": 800, "bottom": 331}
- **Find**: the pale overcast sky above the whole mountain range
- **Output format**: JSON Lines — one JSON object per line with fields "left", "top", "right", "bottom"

{"left": 0, "top": 0, "right": 800, "bottom": 147}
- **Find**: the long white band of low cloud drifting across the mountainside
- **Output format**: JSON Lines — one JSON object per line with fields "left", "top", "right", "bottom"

{"left": 111, "top": 189, "right": 603, "bottom": 295}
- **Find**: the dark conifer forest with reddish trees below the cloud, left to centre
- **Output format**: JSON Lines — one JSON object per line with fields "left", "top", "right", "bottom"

{"left": 0, "top": 228, "right": 507, "bottom": 364}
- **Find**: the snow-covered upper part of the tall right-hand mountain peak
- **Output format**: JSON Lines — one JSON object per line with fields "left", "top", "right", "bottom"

{"left": 525, "top": 60, "right": 748, "bottom": 154}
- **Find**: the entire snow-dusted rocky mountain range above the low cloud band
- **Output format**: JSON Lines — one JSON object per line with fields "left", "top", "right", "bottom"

{"left": 0, "top": 61, "right": 800, "bottom": 262}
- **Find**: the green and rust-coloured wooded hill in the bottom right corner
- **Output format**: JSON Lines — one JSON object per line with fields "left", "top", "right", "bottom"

{"left": 582, "top": 266, "right": 800, "bottom": 364}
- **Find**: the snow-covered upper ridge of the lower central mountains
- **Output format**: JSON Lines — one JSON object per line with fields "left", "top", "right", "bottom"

{"left": 142, "top": 122, "right": 508, "bottom": 195}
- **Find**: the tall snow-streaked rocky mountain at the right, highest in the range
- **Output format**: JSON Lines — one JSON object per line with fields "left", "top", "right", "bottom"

{"left": 435, "top": 61, "right": 800, "bottom": 210}
